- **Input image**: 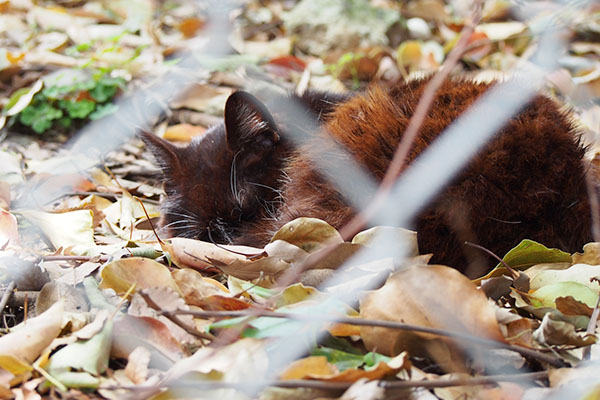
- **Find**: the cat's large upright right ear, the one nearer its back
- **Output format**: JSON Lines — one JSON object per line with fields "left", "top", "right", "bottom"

{"left": 225, "top": 91, "right": 280, "bottom": 166}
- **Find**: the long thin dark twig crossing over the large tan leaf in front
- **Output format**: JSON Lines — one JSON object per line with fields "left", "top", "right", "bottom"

{"left": 163, "top": 310, "right": 567, "bottom": 367}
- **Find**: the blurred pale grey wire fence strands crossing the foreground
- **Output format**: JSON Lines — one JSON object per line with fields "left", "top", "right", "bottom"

{"left": 24, "top": 0, "right": 589, "bottom": 391}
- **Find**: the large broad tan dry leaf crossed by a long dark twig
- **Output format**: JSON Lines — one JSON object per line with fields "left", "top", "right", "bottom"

{"left": 360, "top": 265, "right": 504, "bottom": 355}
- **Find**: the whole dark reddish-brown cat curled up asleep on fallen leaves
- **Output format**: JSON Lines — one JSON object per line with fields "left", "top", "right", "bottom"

{"left": 145, "top": 80, "right": 591, "bottom": 276}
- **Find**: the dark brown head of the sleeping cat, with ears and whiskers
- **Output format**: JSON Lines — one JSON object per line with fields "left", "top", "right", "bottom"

{"left": 141, "top": 91, "right": 288, "bottom": 243}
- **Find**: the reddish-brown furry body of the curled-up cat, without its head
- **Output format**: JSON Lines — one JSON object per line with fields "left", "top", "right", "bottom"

{"left": 284, "top": 79, "right": 590, "bottom": 271}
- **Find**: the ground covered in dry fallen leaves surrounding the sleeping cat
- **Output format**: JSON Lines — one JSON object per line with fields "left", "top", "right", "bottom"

{"left": 0, "top": 0, "right": 600, "bottom": 399}
